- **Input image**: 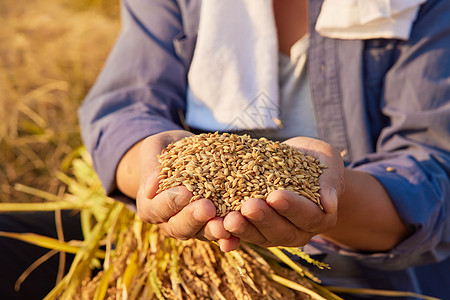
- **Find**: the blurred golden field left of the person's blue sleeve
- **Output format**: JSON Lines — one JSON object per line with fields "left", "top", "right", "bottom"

{"left": 0, "top": 0, "right": 120, "bottom": 202}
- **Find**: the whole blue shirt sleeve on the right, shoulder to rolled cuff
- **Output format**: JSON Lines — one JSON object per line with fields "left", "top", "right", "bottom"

{"left": 351, "top": 1, "right": 450, "bottom": 269}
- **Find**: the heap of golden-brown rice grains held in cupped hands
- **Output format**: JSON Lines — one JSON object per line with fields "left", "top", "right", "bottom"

{"left": 158, "top": 132, "right": 326, "bottom": 217}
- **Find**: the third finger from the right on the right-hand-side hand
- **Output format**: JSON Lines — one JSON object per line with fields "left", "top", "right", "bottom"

{"left": 223, "top": 211, "right": 269, "bottom": 246}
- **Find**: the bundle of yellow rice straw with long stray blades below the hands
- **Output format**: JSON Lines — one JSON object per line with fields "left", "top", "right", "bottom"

{"left": 0, "top": 149, "right": 436, "bottom": 300}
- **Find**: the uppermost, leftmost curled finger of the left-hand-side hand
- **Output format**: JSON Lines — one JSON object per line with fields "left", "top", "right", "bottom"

{"left": 136, "top": 186, "right": 193, "bottom": 224}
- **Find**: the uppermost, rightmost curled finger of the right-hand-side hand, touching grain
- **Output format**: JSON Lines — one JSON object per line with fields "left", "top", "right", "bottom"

{"left": 266, "top": 190, "right": 335, "bottom": 234}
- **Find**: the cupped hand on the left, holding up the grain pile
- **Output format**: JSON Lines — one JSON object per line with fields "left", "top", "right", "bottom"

{"left": 136, "top": 130, "right": 239, "bottom": 251}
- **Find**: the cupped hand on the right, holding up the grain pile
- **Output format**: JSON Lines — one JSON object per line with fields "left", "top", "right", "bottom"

{"left": 223, "top": 137, "right": 344, "bottom": 250}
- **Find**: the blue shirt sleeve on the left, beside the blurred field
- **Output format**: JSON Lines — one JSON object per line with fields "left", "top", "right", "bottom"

{"left": 79, "top": 0, "right": 187, "bottom": 194}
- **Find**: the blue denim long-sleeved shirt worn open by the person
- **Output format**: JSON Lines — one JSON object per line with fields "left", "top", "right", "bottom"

{"left": 79, "top": 0, "right": 450, "bottom": 298}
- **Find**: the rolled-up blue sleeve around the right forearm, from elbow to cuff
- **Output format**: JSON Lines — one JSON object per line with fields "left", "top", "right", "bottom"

{"left": 355, "top": 151, "right": 450, "bottom": 270}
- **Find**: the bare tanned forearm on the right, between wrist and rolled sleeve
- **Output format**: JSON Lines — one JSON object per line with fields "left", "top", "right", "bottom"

{"left": 323, "top": 169, "right": 408, "bottom": 251}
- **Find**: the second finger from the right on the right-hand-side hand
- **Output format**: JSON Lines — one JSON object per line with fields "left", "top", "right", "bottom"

{"left": 241, "top": 198, "right": 312, "bottom": 247}
